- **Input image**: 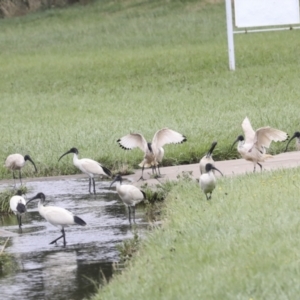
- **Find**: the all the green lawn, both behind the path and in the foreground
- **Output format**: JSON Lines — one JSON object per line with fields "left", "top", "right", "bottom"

{"left": 0, "top": 0, "right": 300, "bottom": 300}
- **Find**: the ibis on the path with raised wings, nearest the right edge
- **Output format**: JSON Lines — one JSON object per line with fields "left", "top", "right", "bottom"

{"left": 232, "top": 117, "right": 288, "bottom": 172}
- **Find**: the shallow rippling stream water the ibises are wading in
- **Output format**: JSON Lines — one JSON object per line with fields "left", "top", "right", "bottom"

{"left": 0, "top": 178, "right": 147, "bottom": 300}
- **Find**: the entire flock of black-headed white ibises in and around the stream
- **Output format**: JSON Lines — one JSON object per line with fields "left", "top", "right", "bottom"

{"left": 5, "top": 117, "right": 300, "bottom": 247}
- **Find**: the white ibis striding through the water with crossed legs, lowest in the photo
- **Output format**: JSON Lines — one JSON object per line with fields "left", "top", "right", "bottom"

{"left": 27, "top": 193, "right": 86, "bottom": 247}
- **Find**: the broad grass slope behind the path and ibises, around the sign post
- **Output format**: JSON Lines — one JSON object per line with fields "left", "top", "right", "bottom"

{"left": 0, "top": 0, "right": 300, "bottom": 178}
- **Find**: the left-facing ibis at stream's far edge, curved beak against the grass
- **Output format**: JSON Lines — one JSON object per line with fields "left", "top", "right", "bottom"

{"left": 58, "top": 148, "right": 111, "bottom": 194}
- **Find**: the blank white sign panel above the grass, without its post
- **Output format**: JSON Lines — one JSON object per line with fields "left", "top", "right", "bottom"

{"left": 234, "top": 0, "right": 300, "bottom": 28}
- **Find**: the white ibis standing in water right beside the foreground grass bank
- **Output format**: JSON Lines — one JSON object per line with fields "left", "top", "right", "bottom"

{"left": 110, "top": 175, "right": 146, "bottom": 224}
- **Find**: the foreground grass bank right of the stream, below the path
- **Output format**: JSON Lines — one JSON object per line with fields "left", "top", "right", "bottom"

{"left": 93, "top": 169, "right": 300, "bottom": 300}
